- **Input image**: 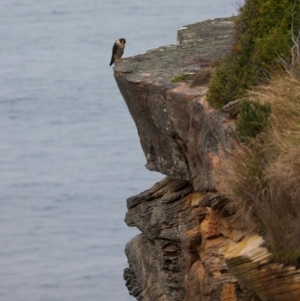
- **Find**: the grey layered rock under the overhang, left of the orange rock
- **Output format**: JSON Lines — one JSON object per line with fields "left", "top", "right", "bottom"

{"left": 124, "top": 177, "right": 196, "bottom": 301}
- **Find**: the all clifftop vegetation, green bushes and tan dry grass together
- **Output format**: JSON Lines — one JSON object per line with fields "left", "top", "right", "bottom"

{"left": 212, "top": 0, "right": 300, "bottom": 266}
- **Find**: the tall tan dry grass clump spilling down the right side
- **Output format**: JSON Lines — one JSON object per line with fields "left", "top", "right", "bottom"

{"left": 227, "top": 68, "right": 300, "bottom": 263}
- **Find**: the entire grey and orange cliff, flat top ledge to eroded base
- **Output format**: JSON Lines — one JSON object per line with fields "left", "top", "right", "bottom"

{"left": 114, "top": 19, "right": 251, "bottom": 301}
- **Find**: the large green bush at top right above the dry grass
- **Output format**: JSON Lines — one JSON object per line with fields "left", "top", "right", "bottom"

{"left": 208, "top": 0, "right": 300, "bottom": 108}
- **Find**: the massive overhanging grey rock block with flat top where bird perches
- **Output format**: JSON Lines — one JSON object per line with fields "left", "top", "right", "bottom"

{"left": 114, "top": 19, "right": 234, "bottom": 191}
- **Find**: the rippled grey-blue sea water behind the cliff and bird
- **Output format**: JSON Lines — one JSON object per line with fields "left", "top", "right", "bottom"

{"left": 0, "top": 0, "right": 236, "bottom": 301}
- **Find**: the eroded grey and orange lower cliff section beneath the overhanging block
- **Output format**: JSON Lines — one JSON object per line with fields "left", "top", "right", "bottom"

{"left": 124, "top": 177, "right": 251, "bottom": 301}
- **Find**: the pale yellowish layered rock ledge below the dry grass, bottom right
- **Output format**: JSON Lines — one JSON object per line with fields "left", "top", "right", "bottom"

{"left": 225, "top": 235, "right": 300, "bottom": 301}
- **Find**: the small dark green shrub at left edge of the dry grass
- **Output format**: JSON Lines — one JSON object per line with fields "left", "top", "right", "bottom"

{"left": 234, "top": 100, "right": 271, "bottom": 142}
